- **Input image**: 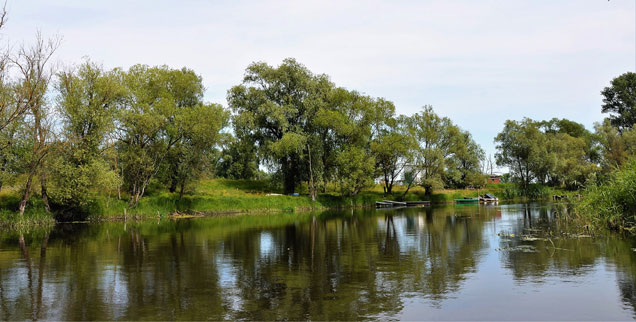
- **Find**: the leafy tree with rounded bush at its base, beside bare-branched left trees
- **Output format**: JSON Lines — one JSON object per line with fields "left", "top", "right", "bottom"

{"left": 48, "top": 61, "right": 126, "bottom": 212}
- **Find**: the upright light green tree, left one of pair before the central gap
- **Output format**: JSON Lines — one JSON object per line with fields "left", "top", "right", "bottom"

{"left": 117, "top": 65, "right": 209, "bottom": 207}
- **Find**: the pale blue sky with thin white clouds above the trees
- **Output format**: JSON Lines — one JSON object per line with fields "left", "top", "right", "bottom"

{"left": 0, "top": 0, "right": 636, "bottom": 166}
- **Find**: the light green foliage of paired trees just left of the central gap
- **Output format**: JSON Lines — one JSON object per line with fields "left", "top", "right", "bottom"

{"left": 117, "top": 65, "right": 229, "bottom": 207}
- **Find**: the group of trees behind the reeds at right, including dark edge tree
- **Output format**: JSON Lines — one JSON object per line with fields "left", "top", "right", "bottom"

{"left": 495, "top": 72, "right": 636, "bottom": 190}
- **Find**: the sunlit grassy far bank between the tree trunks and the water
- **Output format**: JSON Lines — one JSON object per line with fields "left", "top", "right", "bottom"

{"left": 0, "top": 179, "right": 576, "bottom": 228}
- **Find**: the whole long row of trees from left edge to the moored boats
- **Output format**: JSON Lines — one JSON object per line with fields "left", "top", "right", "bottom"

{"left": 0, "top": 32, "right": 484, "bottom": 214}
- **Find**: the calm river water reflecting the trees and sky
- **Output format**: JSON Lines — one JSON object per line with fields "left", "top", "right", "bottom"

{"left": 0, "top": 204, "right": 636, "bottom": 320}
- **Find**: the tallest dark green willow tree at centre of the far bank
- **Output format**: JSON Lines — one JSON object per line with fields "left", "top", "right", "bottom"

{"left": 228, "top": 58, "right": 333, "bottom": 193}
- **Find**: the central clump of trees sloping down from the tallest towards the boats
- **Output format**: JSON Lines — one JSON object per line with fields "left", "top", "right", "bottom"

{"left": 218, "top": 59, "right": 484, "bottom": 198}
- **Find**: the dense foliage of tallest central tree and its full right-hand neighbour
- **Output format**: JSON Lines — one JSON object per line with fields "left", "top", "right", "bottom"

{"left": 229, "top": 59, "right": 396, "bottom": 195}
